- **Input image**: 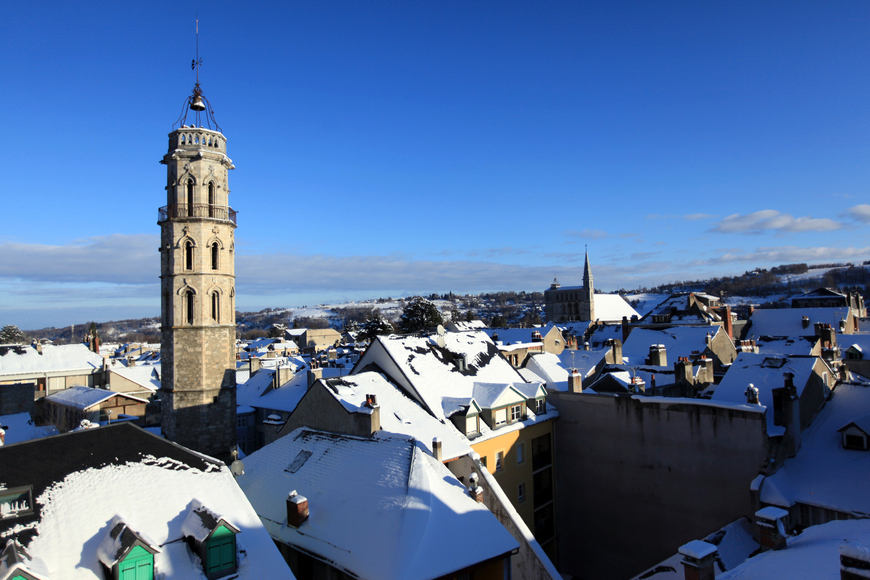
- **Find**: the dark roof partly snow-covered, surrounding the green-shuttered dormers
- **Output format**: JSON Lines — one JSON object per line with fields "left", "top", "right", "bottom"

{"left": 0, "top": 423, "right": 293, "bottom": 580}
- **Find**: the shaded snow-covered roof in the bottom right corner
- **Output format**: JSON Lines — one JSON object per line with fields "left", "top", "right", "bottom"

{"left": 717, "top": 520, "right": 870, "bottom": 580}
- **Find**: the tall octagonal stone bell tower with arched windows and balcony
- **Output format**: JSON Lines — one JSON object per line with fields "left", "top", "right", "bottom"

{"left": 157, "top": 70, "right": 236, "bottom": 458}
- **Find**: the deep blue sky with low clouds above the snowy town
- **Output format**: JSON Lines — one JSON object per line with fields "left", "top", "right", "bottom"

{"left": 0, "top": 1, "right": 870, "bottom": 328}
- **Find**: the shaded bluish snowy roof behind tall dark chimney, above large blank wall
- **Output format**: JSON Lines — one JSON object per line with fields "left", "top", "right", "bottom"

{"left": 712, "top": 352, "right": 818, "bottom": 436}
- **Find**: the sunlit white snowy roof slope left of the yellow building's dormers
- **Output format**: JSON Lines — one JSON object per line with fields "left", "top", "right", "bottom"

{"left": 323, "top": 372, "right": 471, "bottom": 461}
